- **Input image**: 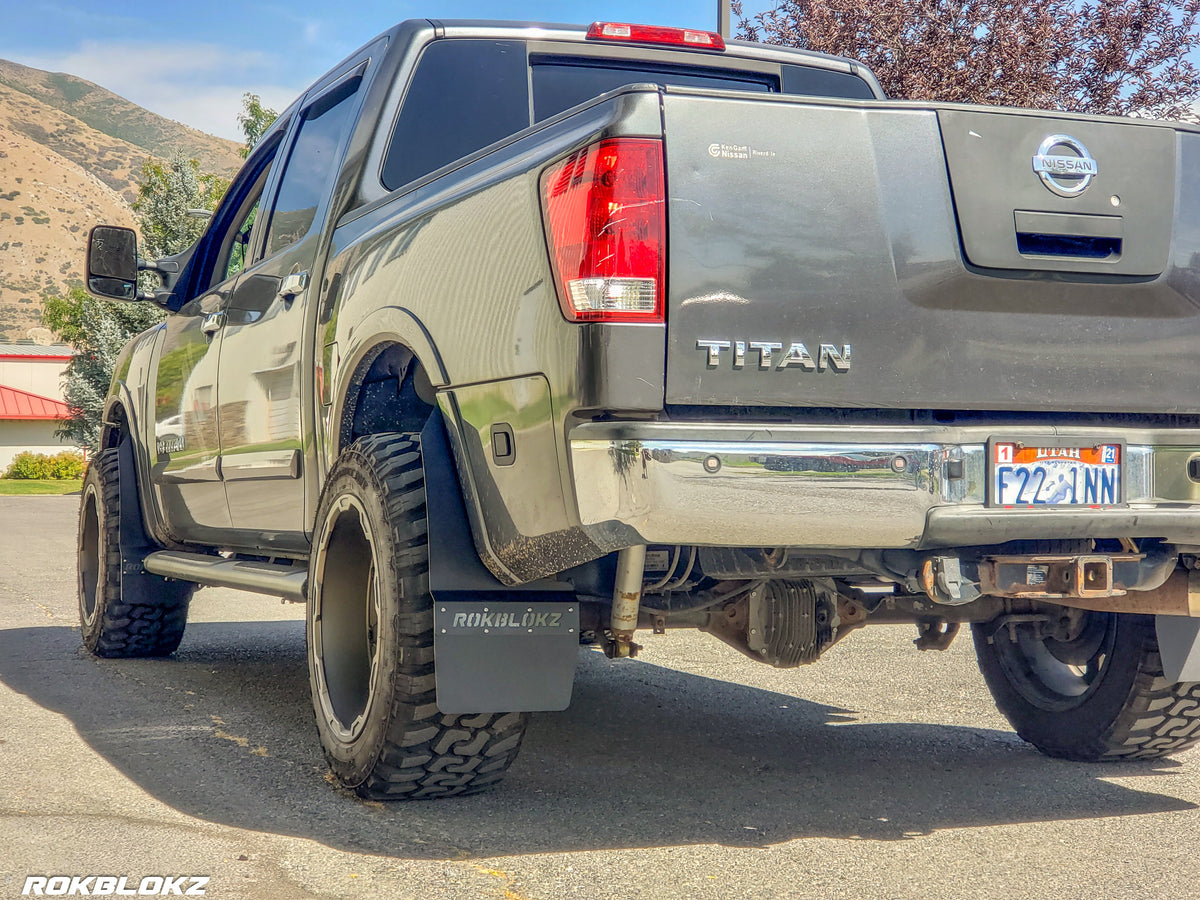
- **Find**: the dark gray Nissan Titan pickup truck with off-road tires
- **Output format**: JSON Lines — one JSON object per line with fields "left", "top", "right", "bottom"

{"left": 79, "top": 20, "right": 1200, "bottom": 798}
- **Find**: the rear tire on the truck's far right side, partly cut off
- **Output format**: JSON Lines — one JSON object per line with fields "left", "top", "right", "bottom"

{"left": 972, "top": 613, "right": 1200, "bottom": 762}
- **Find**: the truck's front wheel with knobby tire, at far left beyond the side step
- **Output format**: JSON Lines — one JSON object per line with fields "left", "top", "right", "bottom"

{"left": 78, "top": 448, "right": 196, "bottom": 658}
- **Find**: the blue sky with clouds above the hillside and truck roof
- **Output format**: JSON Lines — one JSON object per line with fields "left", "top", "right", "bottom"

{"left": 0, "top": 0, "right": 769, "bottom": 139}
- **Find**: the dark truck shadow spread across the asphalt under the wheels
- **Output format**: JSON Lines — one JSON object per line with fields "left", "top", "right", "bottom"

{"left": 0, "top": 622, "right": 1195, "bottom": 859}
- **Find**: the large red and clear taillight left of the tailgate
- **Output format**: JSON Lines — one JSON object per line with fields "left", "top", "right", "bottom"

{"left": 541, "top": 138, "right": 667, "bottom": 322}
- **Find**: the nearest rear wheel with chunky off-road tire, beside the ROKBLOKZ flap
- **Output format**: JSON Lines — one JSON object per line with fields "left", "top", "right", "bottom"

{"left": 307, "top": 434, "right": 529, "bottom": 799}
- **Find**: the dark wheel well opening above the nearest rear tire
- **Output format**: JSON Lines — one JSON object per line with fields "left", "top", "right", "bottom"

{"left": 337, "top": 343, "right": 434, "bottom": 452}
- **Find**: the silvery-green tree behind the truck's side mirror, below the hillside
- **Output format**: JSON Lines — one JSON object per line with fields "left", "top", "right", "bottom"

{"left": 42, "top": 152, "right": 229, "bottom": 451}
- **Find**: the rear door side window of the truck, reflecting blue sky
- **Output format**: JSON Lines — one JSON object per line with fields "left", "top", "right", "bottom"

{"left": 265, "top": 78, "right": 362, "bottom": 256}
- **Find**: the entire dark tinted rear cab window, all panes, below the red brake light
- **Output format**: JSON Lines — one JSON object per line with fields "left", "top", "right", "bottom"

{"left": 382, "top": 37, "right": 875, "bottom": 191}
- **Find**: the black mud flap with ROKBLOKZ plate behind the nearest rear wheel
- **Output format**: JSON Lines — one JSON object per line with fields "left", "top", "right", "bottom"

{"left": 421, "top": 410, "right": 580, "bottom": 713}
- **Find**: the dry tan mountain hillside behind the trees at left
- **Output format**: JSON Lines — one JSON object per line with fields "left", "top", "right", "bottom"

{"left": 0, "top": 60, "right": 241, "bottom": 341}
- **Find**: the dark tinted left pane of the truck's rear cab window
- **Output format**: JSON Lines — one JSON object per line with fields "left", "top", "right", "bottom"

{"left": 383, "top": 40, "right": 529, "bottom": 191}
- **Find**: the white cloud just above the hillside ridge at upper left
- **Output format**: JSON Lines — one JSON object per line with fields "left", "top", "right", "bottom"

{"left": 9, "top": 41, "right": 305, "bottom": 140}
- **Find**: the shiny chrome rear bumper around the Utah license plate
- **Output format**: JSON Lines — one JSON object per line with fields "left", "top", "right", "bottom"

{"left": 569, "top": 424, "right": 1200, "bottom": 548}
